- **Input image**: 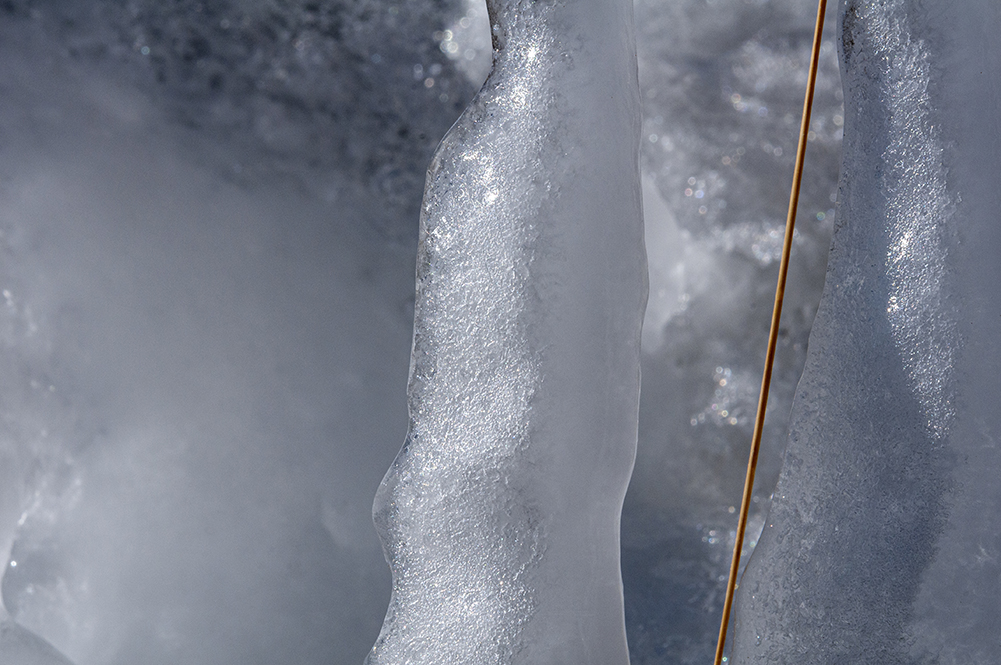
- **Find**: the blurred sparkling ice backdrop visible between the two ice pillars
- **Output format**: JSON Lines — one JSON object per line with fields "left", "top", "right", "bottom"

{"left": 622, "top": 0, "right": 843, "bottom": 665}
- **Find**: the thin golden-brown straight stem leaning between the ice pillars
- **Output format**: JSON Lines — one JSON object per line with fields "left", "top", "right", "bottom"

{"left": 715, "top": 0, "right": 827, "bottom": 665}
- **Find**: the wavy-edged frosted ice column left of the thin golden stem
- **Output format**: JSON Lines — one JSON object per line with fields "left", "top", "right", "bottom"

{"left": 368, "top": 0, "right": 647, "bottom": 665}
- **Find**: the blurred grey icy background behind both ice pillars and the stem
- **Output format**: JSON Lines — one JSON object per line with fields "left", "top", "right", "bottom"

{"left": 0, "top": 0, "right": 842, "bottom": 665}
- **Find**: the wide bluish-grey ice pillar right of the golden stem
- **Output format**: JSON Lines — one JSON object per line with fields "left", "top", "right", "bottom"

{"left": 732, "top": 0, "right": 1001, "bottom": 665}
